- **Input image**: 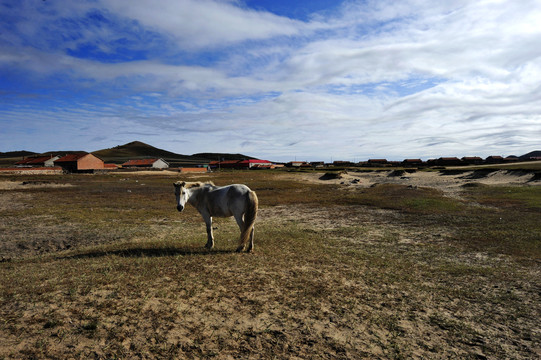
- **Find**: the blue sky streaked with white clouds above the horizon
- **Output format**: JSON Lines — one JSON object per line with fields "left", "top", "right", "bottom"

{"left": 0, "top": 0, "right": 541, "bottom": 161}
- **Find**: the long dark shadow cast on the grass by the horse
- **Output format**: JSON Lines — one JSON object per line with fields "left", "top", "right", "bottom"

{"left": 56, "top": 247, "right": 236, "bottom": 260}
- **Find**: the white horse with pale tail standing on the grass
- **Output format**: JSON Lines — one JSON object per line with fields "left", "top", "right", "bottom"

{"left": 174, "top": 181, "right": 258, "bottom": 252}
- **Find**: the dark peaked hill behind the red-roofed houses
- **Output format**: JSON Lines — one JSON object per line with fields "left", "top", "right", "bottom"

{"left": 92, "top": 141, "right": 253, "bottom": 166}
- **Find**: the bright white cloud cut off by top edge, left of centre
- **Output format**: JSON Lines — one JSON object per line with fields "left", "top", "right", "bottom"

{"left": 102, "top": 0, "right": 304, "bottom": 49}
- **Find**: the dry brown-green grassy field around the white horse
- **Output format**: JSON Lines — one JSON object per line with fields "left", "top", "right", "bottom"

{"left": 0, "top": 171, "right": 541, "bottom": 359}
